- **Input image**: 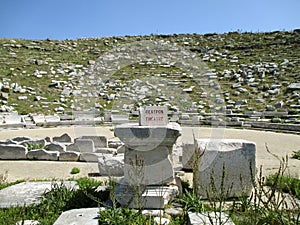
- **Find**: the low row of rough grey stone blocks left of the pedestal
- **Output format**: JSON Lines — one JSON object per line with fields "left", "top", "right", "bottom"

{"left": 0, "top": 133, "right": 117, "bottom": 162}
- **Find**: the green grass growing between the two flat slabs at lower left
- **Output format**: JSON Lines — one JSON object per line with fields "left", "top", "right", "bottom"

{"left": 0, "top": 178, "right": 108, "bottom": 225}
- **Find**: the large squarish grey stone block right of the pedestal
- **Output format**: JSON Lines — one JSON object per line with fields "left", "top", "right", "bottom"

{"left": 193, "top": 139, "right": 256, "bottom": 198}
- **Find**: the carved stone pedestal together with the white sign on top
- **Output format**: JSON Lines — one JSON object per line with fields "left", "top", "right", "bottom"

{"left": 115, "top": 106, "right": 181, "bottom": 209}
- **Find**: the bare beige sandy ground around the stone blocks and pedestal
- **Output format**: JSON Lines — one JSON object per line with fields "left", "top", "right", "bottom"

{"left": 0, "top": 127, "right": 300, "bottom": 182}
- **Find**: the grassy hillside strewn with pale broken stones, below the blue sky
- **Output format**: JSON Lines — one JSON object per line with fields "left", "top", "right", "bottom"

{"left": 0, "top": 30, "right": 300, "bottom": 123}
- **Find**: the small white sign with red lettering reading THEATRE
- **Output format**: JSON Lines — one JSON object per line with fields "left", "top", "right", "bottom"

{"left": 140, "top": 106, "right": 168, "bottom": 126}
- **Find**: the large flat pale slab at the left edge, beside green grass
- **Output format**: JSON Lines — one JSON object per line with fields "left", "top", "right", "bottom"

{"left": 0, "top": 181, "right": 78, "bottom": 208}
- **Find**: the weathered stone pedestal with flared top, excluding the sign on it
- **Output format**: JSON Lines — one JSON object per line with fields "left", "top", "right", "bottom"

{"left": 115, "top": 123, "right": 181, "bottom": 208}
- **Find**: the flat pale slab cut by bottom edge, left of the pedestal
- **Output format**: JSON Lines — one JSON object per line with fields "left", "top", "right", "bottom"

{"left": 53, "top": 208, "right": 100, "bottom": 225}
